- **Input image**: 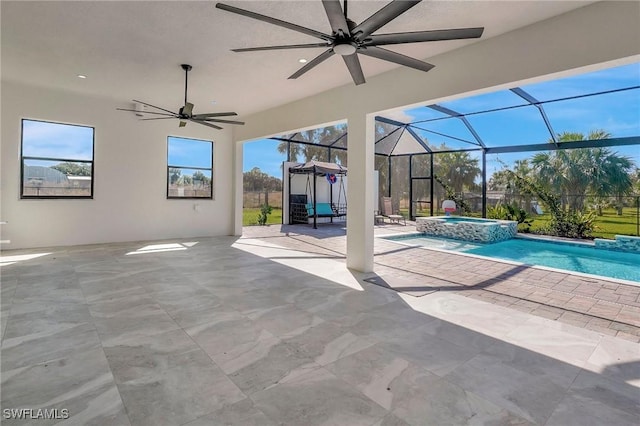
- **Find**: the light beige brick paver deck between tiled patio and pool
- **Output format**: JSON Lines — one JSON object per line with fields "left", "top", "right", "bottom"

{"left": 244, "top": 221, "right": 640, "bottom": 342}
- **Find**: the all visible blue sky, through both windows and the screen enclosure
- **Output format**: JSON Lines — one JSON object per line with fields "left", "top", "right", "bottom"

{"left": 23, "top": 63, "right": 640, "bottom": 178}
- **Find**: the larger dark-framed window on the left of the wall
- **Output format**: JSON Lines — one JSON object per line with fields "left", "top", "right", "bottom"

{"left": 20, "top": 119, "right": 94, "bottom": 198}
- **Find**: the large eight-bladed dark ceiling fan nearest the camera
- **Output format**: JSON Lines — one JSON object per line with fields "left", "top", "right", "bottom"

{"left": 216, "top": 0, "right": 484, "bottom": 85}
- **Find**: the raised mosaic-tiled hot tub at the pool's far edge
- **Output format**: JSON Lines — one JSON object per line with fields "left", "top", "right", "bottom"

{"left": 416, "top": 216, "right": 518, "bottom": 243}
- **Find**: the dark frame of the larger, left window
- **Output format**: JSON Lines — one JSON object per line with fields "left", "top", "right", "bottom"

{"left": 20, "top": 118, "right": 96, "bottom": 200}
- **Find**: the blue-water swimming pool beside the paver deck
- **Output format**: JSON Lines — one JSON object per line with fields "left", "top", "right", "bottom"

{"left": 382, "top": 234, "right": 640, "bottom": 283}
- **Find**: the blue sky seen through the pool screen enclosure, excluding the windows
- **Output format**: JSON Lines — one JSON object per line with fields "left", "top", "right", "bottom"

{"left": 243, "top": 63, "right": 640, "bottom": 177}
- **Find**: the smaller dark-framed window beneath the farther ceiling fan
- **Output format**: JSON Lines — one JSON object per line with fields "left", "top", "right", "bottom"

{"left": 167, "top": 136, "right": 213, "bottom": 198}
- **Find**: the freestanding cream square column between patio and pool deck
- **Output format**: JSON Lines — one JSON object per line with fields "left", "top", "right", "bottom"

{"left": 347, "top": 113, "right": 375, "bottom": 272}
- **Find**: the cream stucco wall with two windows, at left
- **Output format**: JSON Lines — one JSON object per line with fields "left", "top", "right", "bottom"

{"left": 0, "top": 81, "right": 234, "bottom": 249}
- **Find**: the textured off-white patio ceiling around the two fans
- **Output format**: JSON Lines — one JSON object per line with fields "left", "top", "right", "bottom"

{"left": 1, "top": 0, "right": 591, "bottom": 116}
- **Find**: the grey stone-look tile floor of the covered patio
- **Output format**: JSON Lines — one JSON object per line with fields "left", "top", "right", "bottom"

{"left": 1, "top": 235, "right": 640, "bottom": 426}
